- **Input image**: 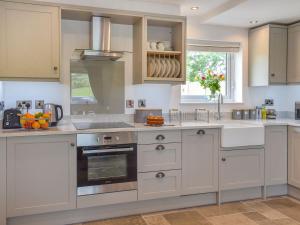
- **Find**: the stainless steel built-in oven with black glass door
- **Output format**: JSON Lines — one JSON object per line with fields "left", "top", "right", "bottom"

{"left": 77, "top": 132, "right": 137, "bottom": 196}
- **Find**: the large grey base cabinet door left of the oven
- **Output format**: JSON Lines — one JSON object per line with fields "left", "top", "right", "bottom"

{"left": 7, "top": 135, "right": 76, "bottom": 217}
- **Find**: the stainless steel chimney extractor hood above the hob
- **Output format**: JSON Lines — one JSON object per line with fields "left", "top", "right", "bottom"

{"left": 81, "top": 16, "right": 123, "bottom": 60}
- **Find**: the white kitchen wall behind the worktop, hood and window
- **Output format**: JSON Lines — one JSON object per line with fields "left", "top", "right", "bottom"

{"left": 3, "top": 13, "right": 300, "bottom": 114}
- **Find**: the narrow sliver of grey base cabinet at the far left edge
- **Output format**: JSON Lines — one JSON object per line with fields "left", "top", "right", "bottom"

{"left": 0, "top": 138, "right": 6, "bottom": 225}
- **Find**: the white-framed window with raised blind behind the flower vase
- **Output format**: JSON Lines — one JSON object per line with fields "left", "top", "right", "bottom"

{"left": 181, "top": 40, "right": 239, "bottom": 103}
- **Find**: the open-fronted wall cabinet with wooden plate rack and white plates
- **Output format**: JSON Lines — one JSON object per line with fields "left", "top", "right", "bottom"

{"left": 133, "top": 16, "right": 186, "bottom": 84}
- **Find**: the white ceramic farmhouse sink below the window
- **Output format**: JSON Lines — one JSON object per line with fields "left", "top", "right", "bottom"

{"left": 221, "top": 122, "right": 265, "bottom": 148}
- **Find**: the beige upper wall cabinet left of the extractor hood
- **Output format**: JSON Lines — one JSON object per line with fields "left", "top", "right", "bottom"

{"left": 0, "top": 1, "right": 60, "bottom": 80}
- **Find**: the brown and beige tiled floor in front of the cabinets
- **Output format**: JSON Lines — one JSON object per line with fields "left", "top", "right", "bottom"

{"left": 75, "top": 197, "right": 300, "bottom": 225}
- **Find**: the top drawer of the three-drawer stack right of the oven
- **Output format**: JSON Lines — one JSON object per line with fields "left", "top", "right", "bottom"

{"left": 138, "top": 130, "right": 181, "bottom": 144}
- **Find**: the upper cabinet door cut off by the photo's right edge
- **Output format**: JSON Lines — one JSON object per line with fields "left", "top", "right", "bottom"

{"left": 287, "top": 23, "right": 300, "bottom": 83}
